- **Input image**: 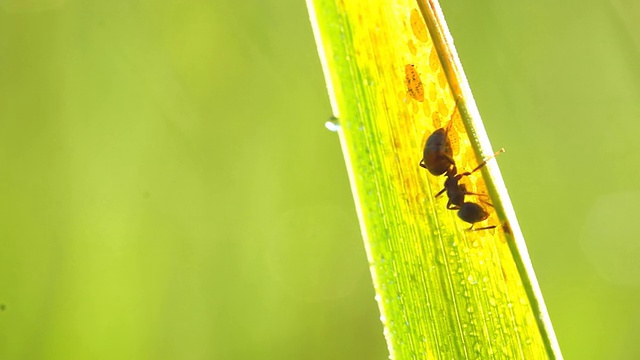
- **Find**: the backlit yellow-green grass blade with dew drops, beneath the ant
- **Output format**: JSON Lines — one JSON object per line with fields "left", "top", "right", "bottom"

{"left": 308, "top": 0, "right": 562, "bottom": 359}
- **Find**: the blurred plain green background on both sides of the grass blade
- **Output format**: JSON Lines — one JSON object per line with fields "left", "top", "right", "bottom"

{"left": 0, "top": 0, "right": 640, "bottom": 359}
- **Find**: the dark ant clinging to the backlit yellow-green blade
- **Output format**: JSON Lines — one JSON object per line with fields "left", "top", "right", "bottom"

{"left": 420, "top": 112, "right": 504, "bottom": 231}
